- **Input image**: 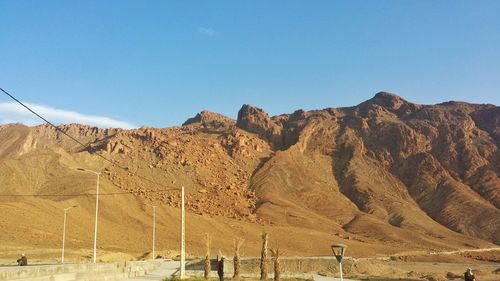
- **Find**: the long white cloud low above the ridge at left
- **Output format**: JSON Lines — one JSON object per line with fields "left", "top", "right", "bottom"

{"left": 0, "top": 102, "right": 137, "bottom": 129}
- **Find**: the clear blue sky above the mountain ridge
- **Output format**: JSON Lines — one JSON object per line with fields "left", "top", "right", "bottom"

{"left": 0, "top": 0, "right": 500, "bottom": 127}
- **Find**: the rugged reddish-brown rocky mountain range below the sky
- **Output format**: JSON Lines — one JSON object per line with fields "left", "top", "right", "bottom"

{"left": 0, "top": 92, "right": 500, "bottom": 255}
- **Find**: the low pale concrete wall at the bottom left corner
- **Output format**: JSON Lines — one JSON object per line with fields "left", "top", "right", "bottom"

{"left": 0, "top": 261, "right": 162, "bottom": 281}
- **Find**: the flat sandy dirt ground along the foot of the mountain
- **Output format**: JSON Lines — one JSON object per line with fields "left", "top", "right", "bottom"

{"left": 0, "top": 248, "right": 500, "bottom": 281}
